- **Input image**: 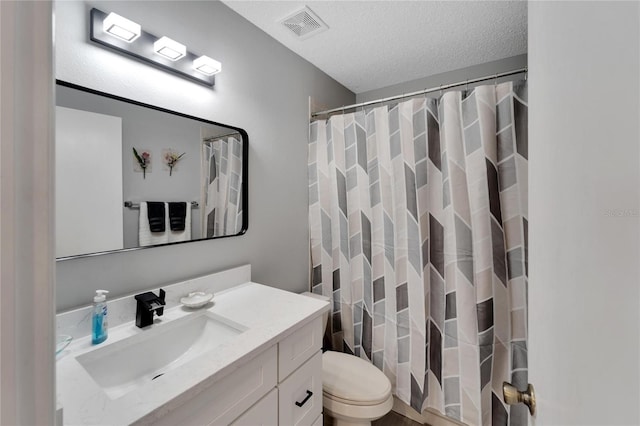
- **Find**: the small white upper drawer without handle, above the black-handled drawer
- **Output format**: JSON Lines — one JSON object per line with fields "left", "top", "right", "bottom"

{"left": 278, "top": 317, "right": 323, "bottom": 382}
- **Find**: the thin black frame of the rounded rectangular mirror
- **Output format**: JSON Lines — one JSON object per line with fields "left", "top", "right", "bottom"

{"left": 56, "top": 79, "right": 249, "bottom": 262}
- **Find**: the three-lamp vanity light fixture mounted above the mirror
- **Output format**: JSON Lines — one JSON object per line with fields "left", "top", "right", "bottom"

{"left": 89, "top": 8, "right": 222, "bottom": 87}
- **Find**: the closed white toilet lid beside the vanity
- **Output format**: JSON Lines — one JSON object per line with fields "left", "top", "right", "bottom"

{"left": 322, "top": 351, "right": 391, "bottom": 405}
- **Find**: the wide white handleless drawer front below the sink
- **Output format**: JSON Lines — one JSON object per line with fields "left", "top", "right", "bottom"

{"left": 153, "top": 346, "right": 277, "bottom": 426}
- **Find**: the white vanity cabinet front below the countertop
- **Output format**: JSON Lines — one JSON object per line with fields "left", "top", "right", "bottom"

{"left": 154, "top": 317, "right": 323, "bottom": 426}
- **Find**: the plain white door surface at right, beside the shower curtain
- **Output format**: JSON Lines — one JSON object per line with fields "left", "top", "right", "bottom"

{"left": 529, "top": 2, "right": 640, "bottom": 425}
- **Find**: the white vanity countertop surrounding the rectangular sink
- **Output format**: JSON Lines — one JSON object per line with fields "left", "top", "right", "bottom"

{"left": 56, "top": 282, "right": 329, "bottom": 425}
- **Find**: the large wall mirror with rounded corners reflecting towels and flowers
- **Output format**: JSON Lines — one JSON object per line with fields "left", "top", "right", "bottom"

{"left": 55, "top": 80, "right": 249, "bottom": 260}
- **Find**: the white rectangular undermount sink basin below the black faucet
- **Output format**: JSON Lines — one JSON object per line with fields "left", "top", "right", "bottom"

{"left": 76, "top": 312, "right": 247, "bottom": 399}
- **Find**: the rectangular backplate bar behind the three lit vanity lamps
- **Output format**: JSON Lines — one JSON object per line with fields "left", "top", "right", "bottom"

{"left": 88, "top": 7, "right": 221, "bottom": 87}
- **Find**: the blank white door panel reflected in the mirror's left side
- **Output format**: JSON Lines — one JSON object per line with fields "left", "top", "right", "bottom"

{"left": 55, "top": 107, "right": 124, "bottom": 257}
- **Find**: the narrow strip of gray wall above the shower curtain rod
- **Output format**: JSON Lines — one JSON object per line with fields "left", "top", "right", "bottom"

{"left": 356, "top": 55, "right": 527, "bottom": 103}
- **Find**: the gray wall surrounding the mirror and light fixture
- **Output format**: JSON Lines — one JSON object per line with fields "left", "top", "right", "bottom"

{"left": 55, "top": 1, "right": 355, "bottom": 311}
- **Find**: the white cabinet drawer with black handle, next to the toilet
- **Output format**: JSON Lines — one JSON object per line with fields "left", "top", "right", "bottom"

{"left": 278, "top": 350, "right": 322, "bottom": 426}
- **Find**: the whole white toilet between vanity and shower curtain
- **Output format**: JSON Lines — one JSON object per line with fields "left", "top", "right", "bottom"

{"left": 303, "top": 292, "right": 393, "bottom": 426}
